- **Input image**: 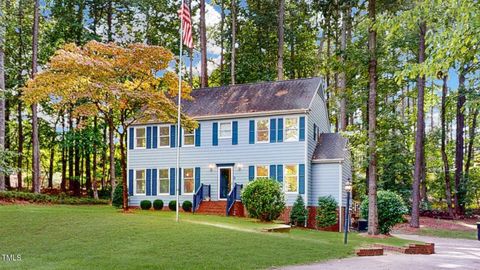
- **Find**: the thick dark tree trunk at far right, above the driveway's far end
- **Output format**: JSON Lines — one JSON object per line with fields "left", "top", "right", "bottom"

{"left": 454, "top": 70, "right": 465, "bottom": 215}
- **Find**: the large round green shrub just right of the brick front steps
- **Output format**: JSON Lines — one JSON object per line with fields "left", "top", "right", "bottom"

{"left": 242, "top": 178, "right": 285, "bottom": 221}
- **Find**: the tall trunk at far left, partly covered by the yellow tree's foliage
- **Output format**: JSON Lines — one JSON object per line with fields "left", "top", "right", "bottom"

{"left": 31, "top": 0, "right": 41, "bottom": 193}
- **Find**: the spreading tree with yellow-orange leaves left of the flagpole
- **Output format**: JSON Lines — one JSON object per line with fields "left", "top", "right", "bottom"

{"left": 23, "top": 41, "right": 197, "bottom": 210}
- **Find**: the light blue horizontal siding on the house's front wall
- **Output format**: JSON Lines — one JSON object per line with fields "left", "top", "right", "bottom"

{"left": 128, "top": 114, "right": 310, "bottom": 206}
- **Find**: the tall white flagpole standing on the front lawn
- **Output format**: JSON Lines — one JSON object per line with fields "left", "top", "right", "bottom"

{"left": 175, "top": 0, "right": 183, "bottom": 222}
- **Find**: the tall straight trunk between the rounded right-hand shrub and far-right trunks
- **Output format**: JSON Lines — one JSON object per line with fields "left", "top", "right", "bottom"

{"left": 410, "top": 22, "right": 427, "bottom": 228}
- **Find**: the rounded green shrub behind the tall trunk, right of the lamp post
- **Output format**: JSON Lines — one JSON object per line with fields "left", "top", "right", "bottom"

{"left": 360, "top": 190, "right": 408, "bottom": 234}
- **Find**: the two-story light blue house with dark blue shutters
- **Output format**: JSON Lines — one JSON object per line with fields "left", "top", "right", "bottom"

{"left": 127, "top": 78, "right": 351, "bottom": 228}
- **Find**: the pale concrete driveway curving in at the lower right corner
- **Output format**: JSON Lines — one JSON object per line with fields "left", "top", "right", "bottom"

{"left": 283, "top": 234, "right": 480, "bottom": 270}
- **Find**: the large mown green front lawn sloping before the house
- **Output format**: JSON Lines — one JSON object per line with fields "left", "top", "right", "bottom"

{"left": 0, "top": 205, "right": 408, "bottom": 269}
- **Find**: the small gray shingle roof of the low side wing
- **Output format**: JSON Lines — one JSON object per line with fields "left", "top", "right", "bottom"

{"left": 312, "top": 133, "right": 348, "bottom": 160}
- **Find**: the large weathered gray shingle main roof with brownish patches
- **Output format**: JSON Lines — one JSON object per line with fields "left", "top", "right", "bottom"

{"left": 182, "top": 77, "right": 322, "bottom": 117}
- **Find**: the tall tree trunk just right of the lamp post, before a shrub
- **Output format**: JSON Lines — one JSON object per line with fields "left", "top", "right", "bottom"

{"left": 368, "top": 0, "right": 379, "bottom": 235}
